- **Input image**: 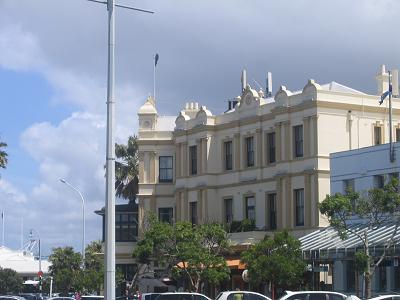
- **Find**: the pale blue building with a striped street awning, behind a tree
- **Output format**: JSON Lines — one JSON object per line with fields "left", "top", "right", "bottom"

{"left": 300, "top": 141, "right": 400, "bottom": 297}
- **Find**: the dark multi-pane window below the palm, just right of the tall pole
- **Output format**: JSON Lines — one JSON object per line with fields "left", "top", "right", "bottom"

{"left": 115, "top": 212, "right": 138, "bottom": 242}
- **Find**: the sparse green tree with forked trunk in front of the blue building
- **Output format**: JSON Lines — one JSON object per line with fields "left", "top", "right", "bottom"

{"left": 319, "top": 178, "right": 400, "bottom": 298}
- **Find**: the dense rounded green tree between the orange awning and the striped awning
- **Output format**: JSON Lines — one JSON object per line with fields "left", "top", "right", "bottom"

{"left": 241, "top": 231, "right": 306, "bottom": 298}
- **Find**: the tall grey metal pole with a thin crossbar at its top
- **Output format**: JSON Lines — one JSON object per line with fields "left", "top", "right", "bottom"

{"left": 87, "top": 0, "right": 154, "bottom": 300}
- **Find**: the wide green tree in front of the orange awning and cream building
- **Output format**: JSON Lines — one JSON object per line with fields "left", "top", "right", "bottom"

{"left": 133, "top": 216, "right": 229, "bottom": 291}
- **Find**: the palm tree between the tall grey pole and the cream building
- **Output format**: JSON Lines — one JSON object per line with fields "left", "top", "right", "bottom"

{"left": 115, "top": 136, "right": 139, "bottom": 201}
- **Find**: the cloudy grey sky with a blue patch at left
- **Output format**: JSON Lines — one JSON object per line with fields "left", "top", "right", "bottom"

{"left": 0, "top": 0, "right": 400, "bottom": 255}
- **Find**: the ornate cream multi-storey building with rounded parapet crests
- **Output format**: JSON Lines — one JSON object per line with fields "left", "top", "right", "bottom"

{"left": 138, "top": 66, "right": 400, "bottom": 236}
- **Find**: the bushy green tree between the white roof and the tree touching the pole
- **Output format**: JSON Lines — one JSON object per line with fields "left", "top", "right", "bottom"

{"left": 49, "top": 247, "right": 83, "bottom": 295}
